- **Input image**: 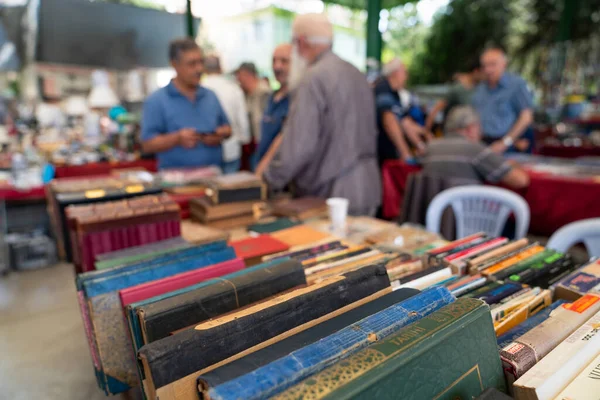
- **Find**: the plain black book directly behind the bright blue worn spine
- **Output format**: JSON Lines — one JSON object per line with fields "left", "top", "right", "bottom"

{"left": 198, "top": 289, "right": 419, "bottom": 398}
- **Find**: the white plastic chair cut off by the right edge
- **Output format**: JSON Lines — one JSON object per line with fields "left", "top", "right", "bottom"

{"left": 546, "top": 218, "right": 600, "bottom": 257}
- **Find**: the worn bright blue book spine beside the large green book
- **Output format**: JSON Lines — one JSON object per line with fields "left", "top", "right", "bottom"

{"left": 198, "top": 287, "right": 455, "bottom": 400}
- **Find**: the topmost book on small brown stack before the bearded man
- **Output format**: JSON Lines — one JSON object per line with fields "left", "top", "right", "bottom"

{"left": 203, "top": 171, "right": 267, "bottom": 204}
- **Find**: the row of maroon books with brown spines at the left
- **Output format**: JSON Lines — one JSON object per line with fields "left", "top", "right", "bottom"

{"left": 65, "top": 194, "right": 181, "bottom": 272}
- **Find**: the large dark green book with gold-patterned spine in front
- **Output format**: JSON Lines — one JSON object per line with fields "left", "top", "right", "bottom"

{"left": 276, "top": 299, "right": 506, "bottom": 400}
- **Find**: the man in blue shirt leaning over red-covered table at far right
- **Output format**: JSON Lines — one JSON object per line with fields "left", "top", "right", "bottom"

{"left": 472, "top": 48, "right": 533, "bottom": 153}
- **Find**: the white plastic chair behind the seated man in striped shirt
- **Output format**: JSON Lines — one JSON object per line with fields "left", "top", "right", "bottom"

{"left": 426, "top": 185, "right": 529, "bottom": 239}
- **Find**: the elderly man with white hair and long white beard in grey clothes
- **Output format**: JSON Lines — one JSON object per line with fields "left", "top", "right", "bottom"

{"left": 264, "top": 14, "right": 381, "bottom": 215}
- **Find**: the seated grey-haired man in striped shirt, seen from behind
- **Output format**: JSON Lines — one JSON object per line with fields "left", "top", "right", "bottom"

{"left": 422, "top": 106, "right": 529, "bottom": 189}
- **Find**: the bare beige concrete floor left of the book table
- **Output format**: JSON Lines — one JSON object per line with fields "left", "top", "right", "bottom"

{"left": 0, "top": 264, "right": 137, "bottom": 400}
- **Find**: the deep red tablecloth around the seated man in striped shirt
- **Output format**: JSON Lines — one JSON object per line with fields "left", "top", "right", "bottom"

{"left": 383, "top": 161, "right": 600, "bottom": 236}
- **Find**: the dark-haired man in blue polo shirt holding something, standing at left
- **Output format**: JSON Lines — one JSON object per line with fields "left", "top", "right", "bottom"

{"left": 142, "top": 38, "right": 231, "bottom": 169}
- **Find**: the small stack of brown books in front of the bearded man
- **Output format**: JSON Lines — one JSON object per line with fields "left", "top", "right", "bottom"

{"left": 190, "top": 172, "right": 266, "bottom": 229}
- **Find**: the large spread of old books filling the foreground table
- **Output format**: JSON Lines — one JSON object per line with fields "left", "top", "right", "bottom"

{"left": 77, "top": 216, "right": 600, "bottom": 400}
